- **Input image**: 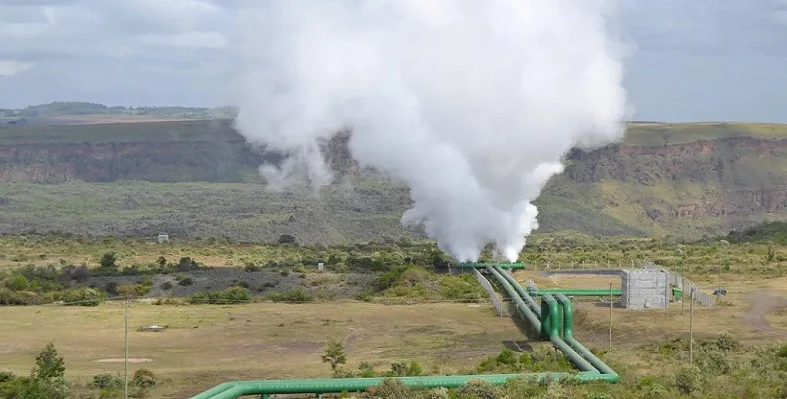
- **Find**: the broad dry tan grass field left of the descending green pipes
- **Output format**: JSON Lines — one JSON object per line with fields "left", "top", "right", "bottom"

{"left": 0, "top": 302, "right": 522, "bottom": 398}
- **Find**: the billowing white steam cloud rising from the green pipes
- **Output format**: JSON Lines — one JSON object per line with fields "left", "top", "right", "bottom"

{"left": 236, "top": 0, "right": 626, "bottom": 261}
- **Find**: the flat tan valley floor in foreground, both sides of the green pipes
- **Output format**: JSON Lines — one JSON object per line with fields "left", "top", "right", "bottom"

{"left": 0, "top": 271, "right": 787, "bottom": 398}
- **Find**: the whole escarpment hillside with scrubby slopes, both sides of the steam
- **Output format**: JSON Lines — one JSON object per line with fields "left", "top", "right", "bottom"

{"left": 0, "top": 120, "right": 787, "bottom": 243}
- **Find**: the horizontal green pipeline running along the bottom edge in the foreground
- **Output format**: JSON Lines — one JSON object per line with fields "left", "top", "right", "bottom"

{"left": 191, "top": 372, "right": 614, "bottom": 399}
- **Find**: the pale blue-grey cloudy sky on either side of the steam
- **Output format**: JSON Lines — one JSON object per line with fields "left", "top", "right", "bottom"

{"left": 0, "top": 0, "right": 787, "bottom": 122}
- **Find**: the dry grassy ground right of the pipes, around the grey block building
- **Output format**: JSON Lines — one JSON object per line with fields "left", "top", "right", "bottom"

{"left": 508, "top": 271, "right": 787, "bottom": 375}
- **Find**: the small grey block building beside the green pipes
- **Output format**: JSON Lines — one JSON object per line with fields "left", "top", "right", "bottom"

{"left": 620, "top": 269, "right": 670, "bottom": 309}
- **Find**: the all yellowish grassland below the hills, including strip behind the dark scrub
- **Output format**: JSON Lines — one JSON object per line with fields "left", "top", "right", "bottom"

{"left": 0, "top": 233, "right": 787, "bottom": 399}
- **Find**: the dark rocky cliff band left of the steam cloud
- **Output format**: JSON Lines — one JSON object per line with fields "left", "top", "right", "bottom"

{"left": 0, "top": 122, "right": 358, "bottom": 183}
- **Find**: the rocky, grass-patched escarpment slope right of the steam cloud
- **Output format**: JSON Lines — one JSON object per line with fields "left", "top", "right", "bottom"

{"left": 542, "top": 137, "right": 787, "bottom": 236}
